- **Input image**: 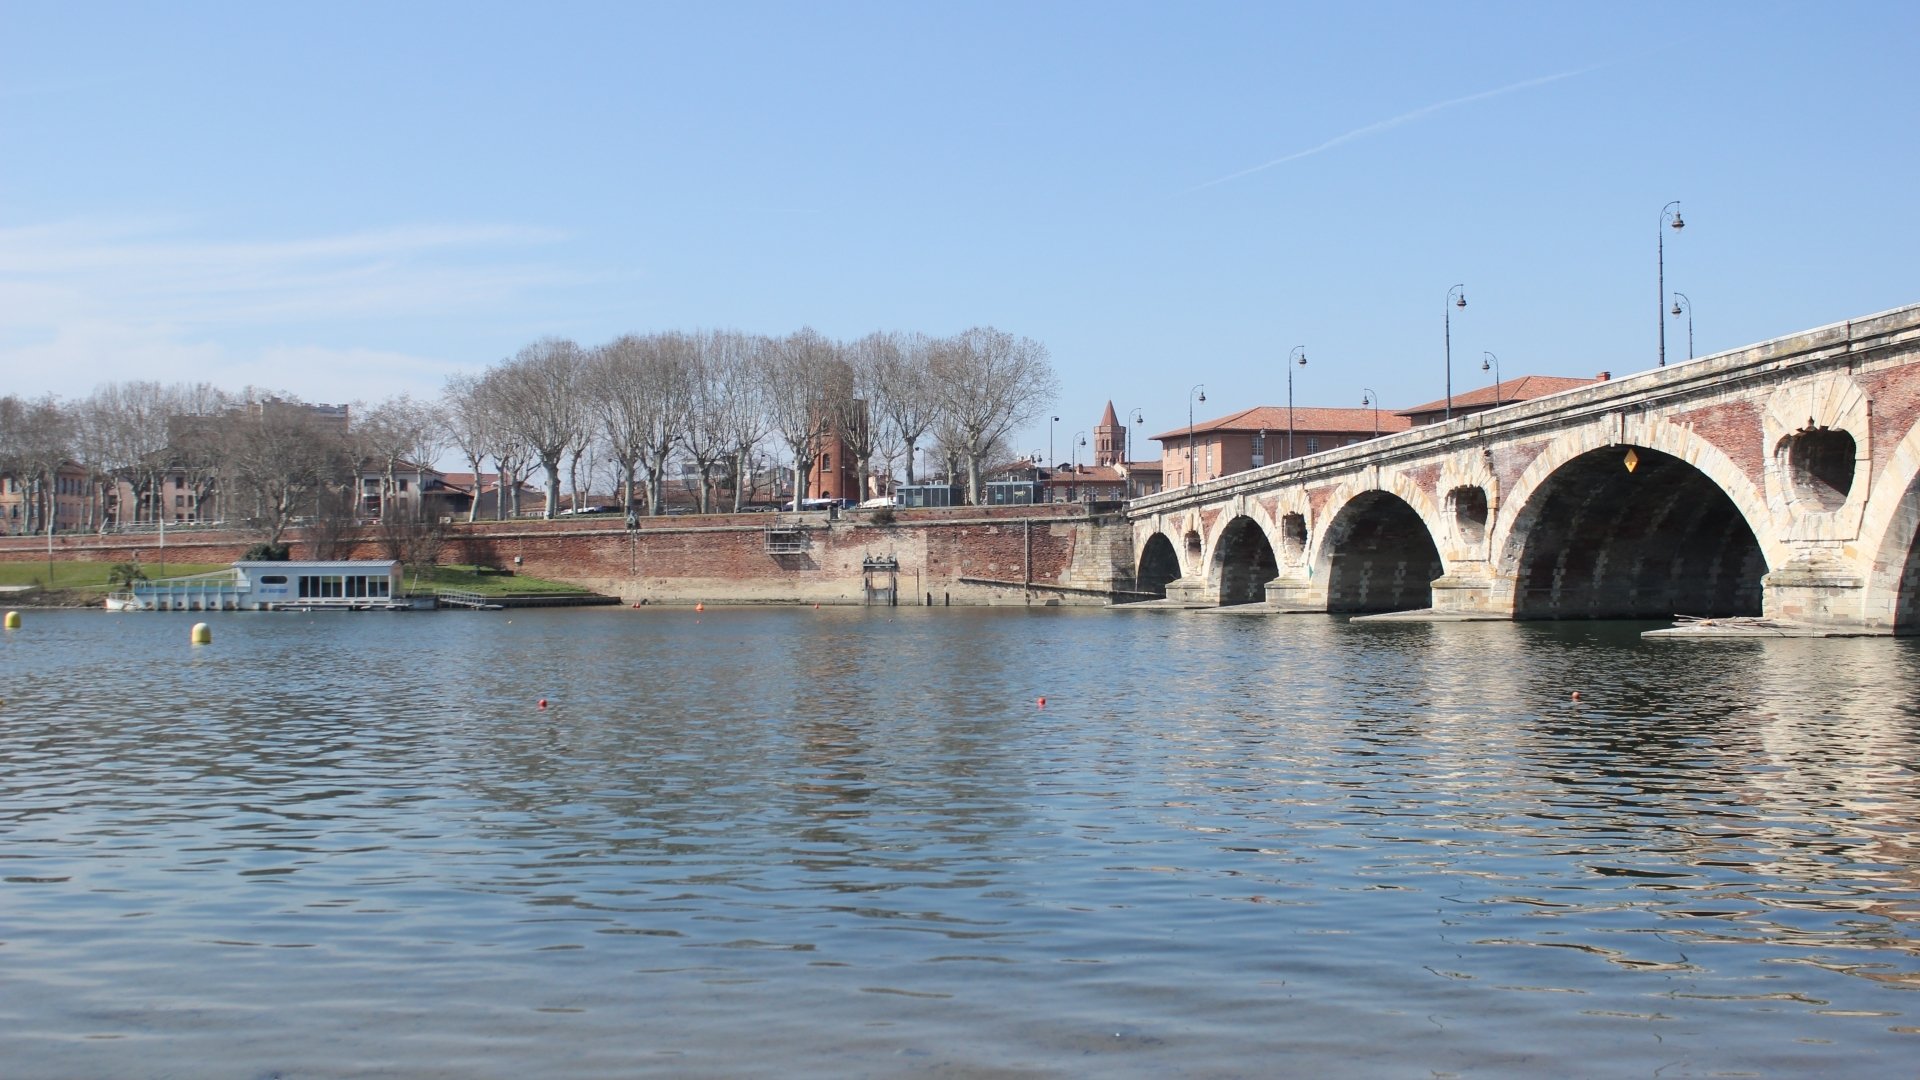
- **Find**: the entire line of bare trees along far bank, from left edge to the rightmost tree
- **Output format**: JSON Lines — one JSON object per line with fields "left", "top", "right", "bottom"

{"left": 0, "top": 320, "right": 1058, "bottom": 542}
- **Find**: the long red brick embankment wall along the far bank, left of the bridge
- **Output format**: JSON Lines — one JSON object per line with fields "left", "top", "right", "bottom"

{"left": 0, "top": 505, "right": 1133, "bottom": 603}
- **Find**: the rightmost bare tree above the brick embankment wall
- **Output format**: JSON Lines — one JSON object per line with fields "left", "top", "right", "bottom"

{"left": 929, "top": 327, "right": 1060, "bottom": 503}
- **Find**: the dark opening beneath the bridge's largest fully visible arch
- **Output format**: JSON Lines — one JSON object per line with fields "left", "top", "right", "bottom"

{"left": 1513, "top": 446, "right": 1766, "bottom": 619}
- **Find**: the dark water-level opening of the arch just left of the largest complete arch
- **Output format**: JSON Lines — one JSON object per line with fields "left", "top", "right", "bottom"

{"left": 1327, "top": 492, "right": 1442, "bottom": 613}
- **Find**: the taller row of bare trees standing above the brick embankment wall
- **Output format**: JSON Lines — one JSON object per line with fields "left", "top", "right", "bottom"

{"left": 455, "top": 327, "right": 1058, "bottom": 513}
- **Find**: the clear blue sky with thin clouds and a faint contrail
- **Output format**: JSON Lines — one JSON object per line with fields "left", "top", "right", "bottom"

{"left": 0, "top": 0, "right": 1920, "bottom": 459}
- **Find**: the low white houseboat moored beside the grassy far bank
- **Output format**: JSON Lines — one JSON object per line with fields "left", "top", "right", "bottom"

{"left": 108, "top": 559, "right": 434, "bottom": 611}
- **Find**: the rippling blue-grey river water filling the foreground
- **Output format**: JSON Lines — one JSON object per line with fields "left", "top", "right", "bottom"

{"left": 0, "top": 607, "right": 1920, "bottom": 1080}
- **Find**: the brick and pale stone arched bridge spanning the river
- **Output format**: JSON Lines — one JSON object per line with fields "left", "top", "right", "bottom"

{"left": 1127, "top": 304, "right": 1920, "bottom": 634}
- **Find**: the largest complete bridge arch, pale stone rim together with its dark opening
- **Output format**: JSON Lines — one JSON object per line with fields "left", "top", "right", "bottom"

{"left": 1492, "top": 421, "right": 1778, "bottom": 619}
